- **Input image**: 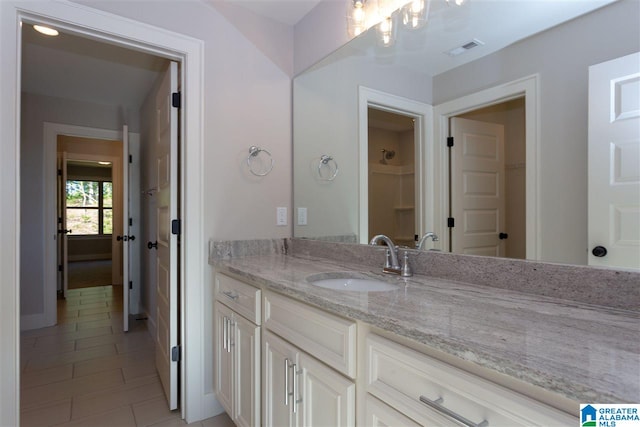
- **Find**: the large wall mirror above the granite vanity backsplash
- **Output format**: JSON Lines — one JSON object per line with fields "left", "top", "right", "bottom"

{"left": 293, "top": 0, "right": 640, "bottom": 265}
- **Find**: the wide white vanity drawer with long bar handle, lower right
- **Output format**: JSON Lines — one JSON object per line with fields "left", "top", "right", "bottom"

{"left": 366, "top": 334, "right": 579, "bottom": 426}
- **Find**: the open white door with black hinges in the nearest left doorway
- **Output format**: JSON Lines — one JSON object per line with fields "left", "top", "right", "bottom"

{"left": 156, "top": 62, "right": 180, "bottom": 410}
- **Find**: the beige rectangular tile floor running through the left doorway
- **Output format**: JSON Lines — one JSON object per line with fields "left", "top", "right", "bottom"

{"left": 20, "top": 286, "right": 233, "bottom": 427}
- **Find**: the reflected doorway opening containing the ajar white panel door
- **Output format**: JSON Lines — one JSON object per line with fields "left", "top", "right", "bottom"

{"left": 449, "top": 97, "right": 526, "bottom": 259}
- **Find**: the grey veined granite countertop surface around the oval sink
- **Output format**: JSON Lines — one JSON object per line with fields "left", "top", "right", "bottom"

{"left": 215, "top": 255, "right": 640, "bottom": 403}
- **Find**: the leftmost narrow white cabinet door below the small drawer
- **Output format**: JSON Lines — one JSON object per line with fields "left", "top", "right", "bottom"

{"left": 214, "top": 301, "right": 233, "bottom": 417}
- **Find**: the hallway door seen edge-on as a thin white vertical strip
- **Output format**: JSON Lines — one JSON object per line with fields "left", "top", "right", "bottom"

{"left": 121, "top": 125, "right": 130, "bottom": 332}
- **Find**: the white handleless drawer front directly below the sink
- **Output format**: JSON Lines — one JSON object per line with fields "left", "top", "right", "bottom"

{"left": 264, "top": 292, "right": 356, "bottom": 378}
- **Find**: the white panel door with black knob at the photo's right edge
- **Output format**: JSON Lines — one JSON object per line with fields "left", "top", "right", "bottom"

{"left": 588, "top": 53, "right": 640, "bottom": 269}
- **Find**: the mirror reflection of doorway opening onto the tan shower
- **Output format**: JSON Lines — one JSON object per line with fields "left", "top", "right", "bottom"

{"left": 367, "top": 107, "right": 417, "bottom": 247}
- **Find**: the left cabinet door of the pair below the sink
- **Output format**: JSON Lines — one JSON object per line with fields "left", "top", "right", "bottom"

{"left": 262, "top": 331, "right": 299, "bottom": 427}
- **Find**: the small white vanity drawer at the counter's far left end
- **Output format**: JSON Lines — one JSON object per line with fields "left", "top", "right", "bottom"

{"left": 215, "top": 274, "right": 262, "bottom": 325}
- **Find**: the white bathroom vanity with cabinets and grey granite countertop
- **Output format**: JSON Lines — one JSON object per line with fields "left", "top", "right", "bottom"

{"left": 212, "top": 239, "right": 640, "bottom": 426}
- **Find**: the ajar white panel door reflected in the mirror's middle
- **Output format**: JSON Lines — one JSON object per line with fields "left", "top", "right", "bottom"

{"left": 450, "top": 117, "right": 506, "bottom": 256}
